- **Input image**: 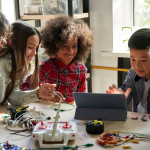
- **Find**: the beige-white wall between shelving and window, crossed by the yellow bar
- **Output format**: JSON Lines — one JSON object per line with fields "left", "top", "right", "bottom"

{"left": 90, "top": 0, "right": 117, "bottom": 93}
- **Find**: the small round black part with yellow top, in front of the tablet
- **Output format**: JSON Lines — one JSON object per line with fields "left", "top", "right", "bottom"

{"left": 86, "top": 120, "right": 104, "bottom": 134}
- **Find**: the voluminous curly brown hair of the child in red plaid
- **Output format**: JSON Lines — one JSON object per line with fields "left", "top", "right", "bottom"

{"left": 41, "top": 15, "right": 93, "bottom": 63}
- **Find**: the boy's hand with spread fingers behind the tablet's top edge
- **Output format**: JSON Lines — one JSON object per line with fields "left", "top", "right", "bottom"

{"left": 106, "top": 84, "right": 131, "bottom": 98}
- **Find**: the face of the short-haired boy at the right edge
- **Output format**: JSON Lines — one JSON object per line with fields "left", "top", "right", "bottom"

{"left": 130, "top": 49, "right": 150, "bottom": 80}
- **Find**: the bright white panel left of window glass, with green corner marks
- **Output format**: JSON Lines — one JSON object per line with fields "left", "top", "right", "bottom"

{"left": 112, "top": 0, "right": 133, "bottom": 52}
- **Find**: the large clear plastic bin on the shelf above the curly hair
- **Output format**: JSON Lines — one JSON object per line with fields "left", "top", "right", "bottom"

{"left": 41, "top": 0, "right": 68, "bottom": 15}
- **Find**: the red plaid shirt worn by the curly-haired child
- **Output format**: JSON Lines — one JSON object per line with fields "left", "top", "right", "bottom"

{"left": 21, "top": 57, "right": 86, "bottom": 103}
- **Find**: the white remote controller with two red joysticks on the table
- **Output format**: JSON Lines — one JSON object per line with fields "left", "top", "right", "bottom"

{"left": 32, "top": 121, "right": 77, "bottom": 148}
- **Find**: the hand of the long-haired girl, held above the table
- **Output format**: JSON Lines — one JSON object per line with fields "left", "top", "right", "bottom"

{"left": 37, "top": 83, "right": 56, "bottom": 98}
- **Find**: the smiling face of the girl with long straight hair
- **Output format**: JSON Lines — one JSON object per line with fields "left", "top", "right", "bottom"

{"left": 26, "top": 35, "right": 39, "bottom": 64}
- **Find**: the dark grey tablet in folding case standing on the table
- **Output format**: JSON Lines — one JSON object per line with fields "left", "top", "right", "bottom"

{"left": 73, "top": 92, "right": 127, "bottom": 121}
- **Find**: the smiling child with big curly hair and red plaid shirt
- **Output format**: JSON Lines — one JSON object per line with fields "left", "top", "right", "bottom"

{"left": 22, "top": 15, "right": 93, "bottom": 104}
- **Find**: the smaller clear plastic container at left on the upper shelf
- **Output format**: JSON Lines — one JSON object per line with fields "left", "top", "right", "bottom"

{"left": 24, "top": 5, "right": 43, "bottom": 15}
